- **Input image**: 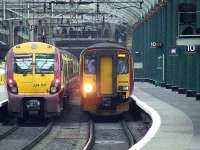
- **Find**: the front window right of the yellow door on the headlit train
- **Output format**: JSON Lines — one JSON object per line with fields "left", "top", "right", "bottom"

{"left": 117, "top": 58, "right": 128, "bottom": 74}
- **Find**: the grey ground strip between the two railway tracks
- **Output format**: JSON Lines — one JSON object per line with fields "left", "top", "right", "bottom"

{"left": 32, "top": 97, "right": 89, "bottom": 150}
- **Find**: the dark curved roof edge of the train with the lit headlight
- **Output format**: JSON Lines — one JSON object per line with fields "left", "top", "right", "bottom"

{"left": 86, "top": 42, "right": 128, "bottom": 50}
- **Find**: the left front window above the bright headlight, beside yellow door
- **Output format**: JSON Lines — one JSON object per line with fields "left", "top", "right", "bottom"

{"left": 85, "top": 55, "right": 96, "bottom": 74}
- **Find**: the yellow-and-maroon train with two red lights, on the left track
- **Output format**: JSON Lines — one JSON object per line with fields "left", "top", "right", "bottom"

{"left": 6, "top": 42, "right": 79, "bottom": 118}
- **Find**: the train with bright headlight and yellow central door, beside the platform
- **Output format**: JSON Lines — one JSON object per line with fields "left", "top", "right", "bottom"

{"left": 80, "top": 43, "right": 133, "bottom": 115}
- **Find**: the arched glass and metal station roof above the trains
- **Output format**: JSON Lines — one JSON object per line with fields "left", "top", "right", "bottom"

{"left": 0, "top": 0, "right": 159, "bottom": 26}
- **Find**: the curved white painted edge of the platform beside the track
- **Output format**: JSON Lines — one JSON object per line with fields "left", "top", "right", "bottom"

{"left": 129, "top": 94, "right": 161, "bottom": 150}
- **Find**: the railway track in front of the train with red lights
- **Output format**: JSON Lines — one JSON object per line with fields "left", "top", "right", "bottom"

{"left": 0, "top": 121, "right": 54, "bottom": 150}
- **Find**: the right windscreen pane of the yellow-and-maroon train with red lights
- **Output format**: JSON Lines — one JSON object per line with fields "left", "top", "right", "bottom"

{"left": 35, "top": 54, "right": 55, "bottom": 73}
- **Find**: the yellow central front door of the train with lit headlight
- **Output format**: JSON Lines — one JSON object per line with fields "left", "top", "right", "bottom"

{"left": 100, "top": 56, "right": 113, "bottom": 95}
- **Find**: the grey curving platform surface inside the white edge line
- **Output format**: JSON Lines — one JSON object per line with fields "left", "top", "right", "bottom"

{"left": 134, "top": 82, "right": 200, "bottom": 150}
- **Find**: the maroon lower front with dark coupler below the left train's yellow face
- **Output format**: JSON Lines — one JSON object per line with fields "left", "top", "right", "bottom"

{"left": 8, "top": 91, "right": 63, "bottom": 119}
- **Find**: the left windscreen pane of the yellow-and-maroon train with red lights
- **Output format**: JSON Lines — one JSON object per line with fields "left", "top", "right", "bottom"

{"left": 14, "top": 55, "right": 33, "bottom": 74}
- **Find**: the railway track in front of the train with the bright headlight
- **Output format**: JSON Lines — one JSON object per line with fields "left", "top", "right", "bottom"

{"left": 83, "top": 120, "right": 135, "bottom": 150}
